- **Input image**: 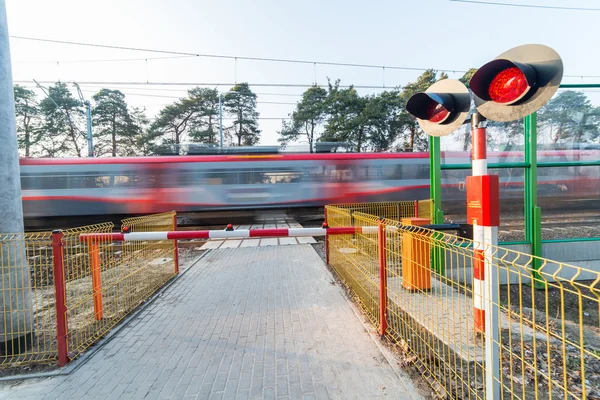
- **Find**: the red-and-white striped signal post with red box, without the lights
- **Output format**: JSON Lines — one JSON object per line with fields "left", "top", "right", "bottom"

{"left": 467, "top": 113, "right": 500, "bottom": 398}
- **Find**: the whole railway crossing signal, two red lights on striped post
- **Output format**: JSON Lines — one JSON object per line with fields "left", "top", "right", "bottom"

{"left": 406, "top": 44, "right": 563, "bottom": 399}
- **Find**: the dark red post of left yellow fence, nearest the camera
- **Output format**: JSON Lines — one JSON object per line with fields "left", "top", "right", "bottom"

{"left": 52, "top": 230, "right": 69, "bottom": 367}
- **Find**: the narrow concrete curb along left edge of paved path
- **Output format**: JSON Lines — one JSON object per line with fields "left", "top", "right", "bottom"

{"left": 0, "top": 249, "right": 211, "bottom": 382}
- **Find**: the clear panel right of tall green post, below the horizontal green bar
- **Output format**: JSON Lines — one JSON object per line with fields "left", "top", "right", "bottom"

{"left": 538, "top": 165, "right": 600, "bottom": 240}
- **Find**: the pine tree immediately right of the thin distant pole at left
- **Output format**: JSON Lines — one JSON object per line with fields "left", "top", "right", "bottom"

{"left": 92, "top": 89, "right": 140, "bottom": 157}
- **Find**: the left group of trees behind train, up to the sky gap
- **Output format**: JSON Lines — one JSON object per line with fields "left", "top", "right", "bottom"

{"left": 14, "top": 82, "right": 260, "bottom": 157}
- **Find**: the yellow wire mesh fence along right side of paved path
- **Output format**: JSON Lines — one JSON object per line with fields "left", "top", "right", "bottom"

{"left": 327, "top": 206, "right": 600, "bottom": 399}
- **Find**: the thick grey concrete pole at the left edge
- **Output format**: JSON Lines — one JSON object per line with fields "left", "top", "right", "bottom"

{"left": 0, "top": 0, "right": 32, "bottom": 354}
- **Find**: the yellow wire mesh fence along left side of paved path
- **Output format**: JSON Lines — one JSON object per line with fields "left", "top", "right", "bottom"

{"left": 0, "top": 213, "right": 178, "bottom": 367}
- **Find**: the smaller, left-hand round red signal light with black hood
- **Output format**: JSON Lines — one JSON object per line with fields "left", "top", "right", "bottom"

{"left": 406, "top": 79, "right": 471, "bottom": 136}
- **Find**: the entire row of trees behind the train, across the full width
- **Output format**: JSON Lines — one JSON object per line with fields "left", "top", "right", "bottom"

{"left": 14, "top": 69, "right": 600, "bottom": 157}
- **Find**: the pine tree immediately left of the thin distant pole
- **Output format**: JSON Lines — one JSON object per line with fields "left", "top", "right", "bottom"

{"left": 40, "top": 82, "right": 86, "bottom": 157}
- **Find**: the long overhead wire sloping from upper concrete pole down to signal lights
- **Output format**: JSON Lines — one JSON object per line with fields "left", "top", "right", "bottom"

{"left": 10, "top": 36, "right": 467, "bottom": 73}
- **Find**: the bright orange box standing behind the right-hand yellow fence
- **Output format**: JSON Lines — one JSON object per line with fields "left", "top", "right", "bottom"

{"left": 402, "top": 218, "right": 431, "bottom": 290}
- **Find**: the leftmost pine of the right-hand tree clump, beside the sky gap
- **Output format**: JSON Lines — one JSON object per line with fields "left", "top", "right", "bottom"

{"left": 279, "top": 86, "right": 327, "bottom": 153}
